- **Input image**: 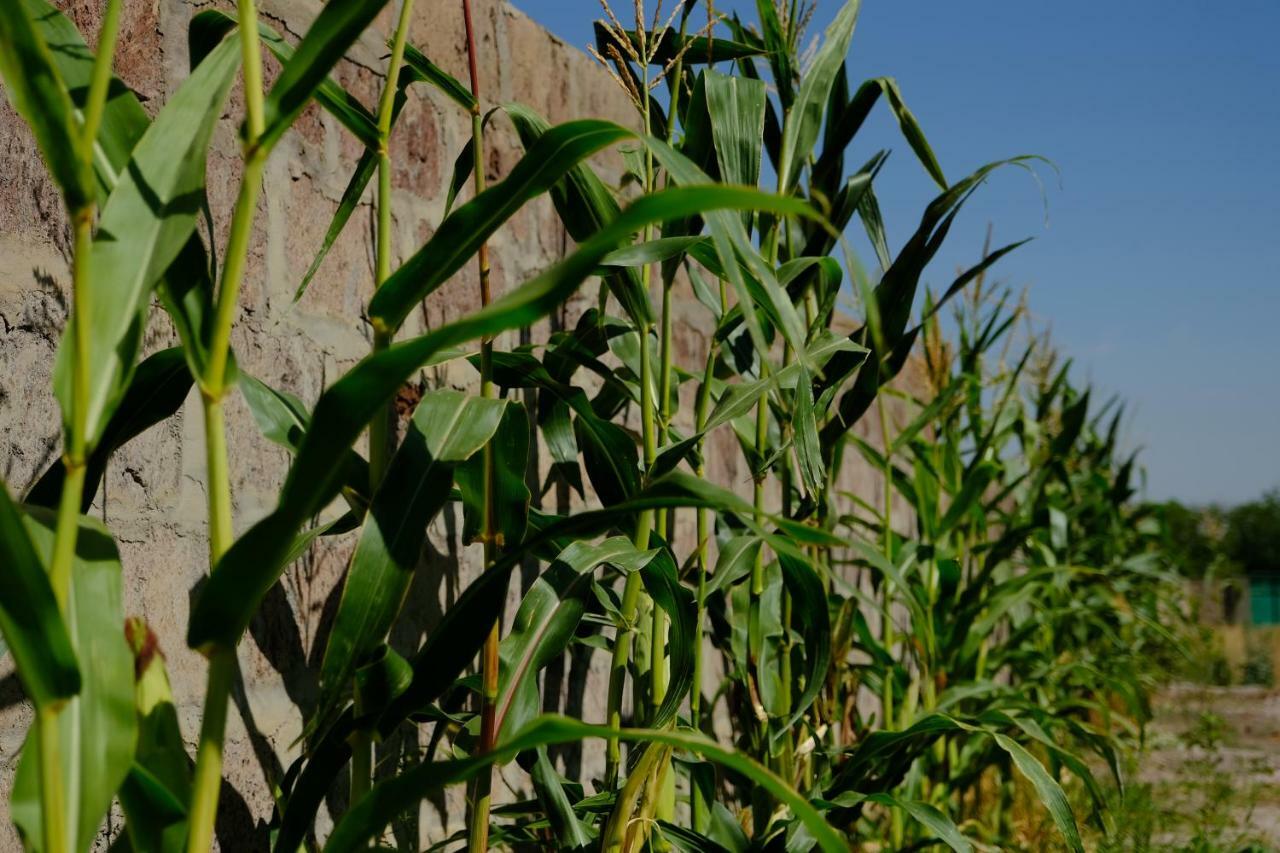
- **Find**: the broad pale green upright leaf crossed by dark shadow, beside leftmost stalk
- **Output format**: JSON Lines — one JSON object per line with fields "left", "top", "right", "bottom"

{"left": 54, "top": 34, "right": 239, "bottom": 448}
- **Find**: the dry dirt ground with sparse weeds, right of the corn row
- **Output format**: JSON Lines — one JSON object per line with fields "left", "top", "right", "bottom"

{"left": 1117, "top": 684, "right": 1280, "bottom": 853}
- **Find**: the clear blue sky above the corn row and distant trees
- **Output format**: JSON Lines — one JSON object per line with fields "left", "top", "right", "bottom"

{"left": 515, "top": 0, "right": 1280, "bottom": 502}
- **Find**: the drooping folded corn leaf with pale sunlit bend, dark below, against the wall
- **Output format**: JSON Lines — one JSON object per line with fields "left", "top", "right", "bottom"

{"left": 311, "top": 391, "right": 507, "bottom": 730}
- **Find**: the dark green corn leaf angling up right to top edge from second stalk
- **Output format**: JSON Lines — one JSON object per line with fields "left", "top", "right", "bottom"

{"left": 257, "top": 0, "right": 387, "bottom": 150}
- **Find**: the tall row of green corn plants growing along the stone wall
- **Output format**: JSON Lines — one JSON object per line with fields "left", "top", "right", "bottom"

{"left": 0, "top": 0, "right": 1176, "bottom": 853}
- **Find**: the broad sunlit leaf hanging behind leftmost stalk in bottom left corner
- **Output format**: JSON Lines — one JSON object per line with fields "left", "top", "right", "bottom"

{"left": 12, "top": 508, "right": 137, "bottom": 850}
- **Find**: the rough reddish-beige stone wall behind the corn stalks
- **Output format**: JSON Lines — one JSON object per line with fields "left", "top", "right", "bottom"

{"left": 0, "top": 0, "right": 921, "bottom": 850}
